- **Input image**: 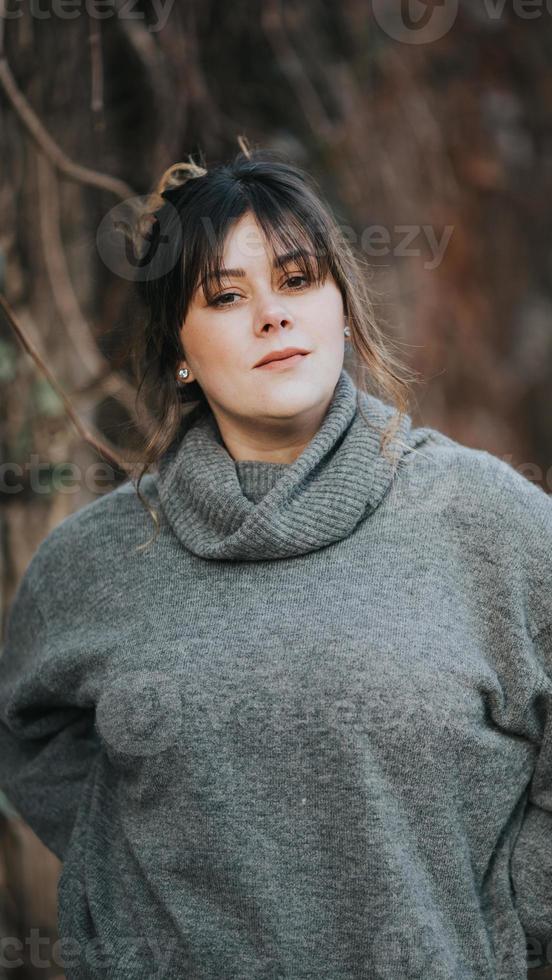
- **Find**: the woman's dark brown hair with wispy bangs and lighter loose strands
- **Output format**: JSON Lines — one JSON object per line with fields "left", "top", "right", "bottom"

{"left": 127, "top": 138, "right": 413, "bottom": 547}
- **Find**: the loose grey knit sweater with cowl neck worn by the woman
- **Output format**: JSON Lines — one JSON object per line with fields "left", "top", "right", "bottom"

{"left": 0, "top": 370, "right": 552, "bottom": 980}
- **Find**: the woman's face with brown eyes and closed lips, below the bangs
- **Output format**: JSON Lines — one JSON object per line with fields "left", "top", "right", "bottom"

{"left": 179, "top": 212, "right": 344, "bottom": 458}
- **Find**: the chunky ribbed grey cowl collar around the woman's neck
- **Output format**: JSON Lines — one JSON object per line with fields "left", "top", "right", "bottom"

{"left": 155, "top": 368, "right": 411, "bottom": 561}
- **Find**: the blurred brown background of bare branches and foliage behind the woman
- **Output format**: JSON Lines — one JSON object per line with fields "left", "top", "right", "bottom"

{"left": 0, "top": 0, "right": 552, "bottom": 977}
